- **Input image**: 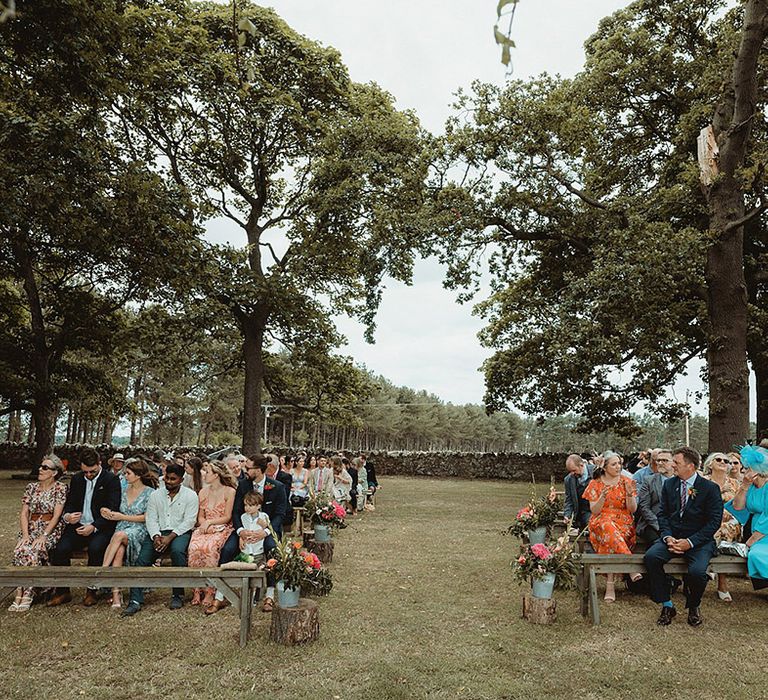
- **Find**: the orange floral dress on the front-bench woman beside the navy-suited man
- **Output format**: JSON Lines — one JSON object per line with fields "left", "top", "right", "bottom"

{"left": 583, "top": 474, "right": 637, "bottom": 554}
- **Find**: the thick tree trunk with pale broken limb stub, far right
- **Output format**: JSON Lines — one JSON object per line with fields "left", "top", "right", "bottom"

{"left": 705, "top": 0, "right": 768, "bottom": 451}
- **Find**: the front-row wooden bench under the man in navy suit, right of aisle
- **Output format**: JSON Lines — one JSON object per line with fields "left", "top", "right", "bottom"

{"left": 576, "top": 554, "right": 747, "bottom": 625}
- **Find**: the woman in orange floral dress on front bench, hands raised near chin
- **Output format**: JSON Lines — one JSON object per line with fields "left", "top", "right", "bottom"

{"left": 583, "top": 452, "right": 641, "bottom": 602}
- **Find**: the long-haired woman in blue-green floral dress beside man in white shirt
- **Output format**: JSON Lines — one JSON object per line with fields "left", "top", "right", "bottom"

{"left": 101, "top": 459, "right": 158, "bottom": 609}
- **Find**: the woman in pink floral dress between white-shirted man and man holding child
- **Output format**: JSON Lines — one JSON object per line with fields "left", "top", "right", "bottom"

{"left": 187, "top": 460, "right": 237, "bottom": 608}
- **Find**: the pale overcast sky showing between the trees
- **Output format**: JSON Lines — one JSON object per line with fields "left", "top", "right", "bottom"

{"left": 209, "top": 0, "right": 756, "bottom": 412}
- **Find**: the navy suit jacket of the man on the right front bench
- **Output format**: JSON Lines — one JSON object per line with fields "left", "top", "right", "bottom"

{"left": 658, "top": 474, "right": 723, "bottom": 547}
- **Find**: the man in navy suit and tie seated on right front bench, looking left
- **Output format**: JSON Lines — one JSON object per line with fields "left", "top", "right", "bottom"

{"left": 644, "top": 447, "right": 723, "bottom": 627}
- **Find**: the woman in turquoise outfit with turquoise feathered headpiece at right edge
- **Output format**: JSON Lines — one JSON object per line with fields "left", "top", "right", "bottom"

{"left": 733, "top": 445, "right": 768, "bottom": 590}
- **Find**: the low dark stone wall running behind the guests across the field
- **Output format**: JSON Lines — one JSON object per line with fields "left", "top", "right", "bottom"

{"left": 0, "top": 443, "right": 567, "bottom": 483}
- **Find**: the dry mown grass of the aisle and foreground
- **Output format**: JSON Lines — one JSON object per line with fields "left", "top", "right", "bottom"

{"left": 0, "top": 475, "right": 768, "bottom": 700}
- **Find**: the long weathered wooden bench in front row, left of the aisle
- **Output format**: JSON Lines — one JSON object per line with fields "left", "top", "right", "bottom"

{"left": 0, "top": 566, "right": 267, "bottom": 647}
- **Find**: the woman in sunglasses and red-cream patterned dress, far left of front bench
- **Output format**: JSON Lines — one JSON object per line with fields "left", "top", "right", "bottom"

{"left": 8, "top": 454, "right": 67, "bottom": 612}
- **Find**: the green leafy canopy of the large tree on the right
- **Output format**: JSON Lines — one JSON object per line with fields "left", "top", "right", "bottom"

{"left": 436, "top": 0, "right": 768, "bottom": 437}
